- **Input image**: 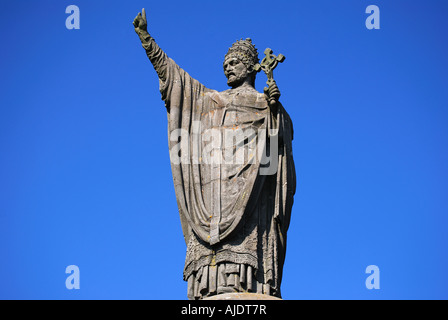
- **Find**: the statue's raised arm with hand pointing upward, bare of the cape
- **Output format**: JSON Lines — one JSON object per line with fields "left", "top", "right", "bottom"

{"left": 133, "top": 8, "right": 168, "bottom": 82}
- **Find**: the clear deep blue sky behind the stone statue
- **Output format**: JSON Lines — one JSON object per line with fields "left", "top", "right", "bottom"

{"left": 0, "top": 0, "right": 448, "bottom": 299}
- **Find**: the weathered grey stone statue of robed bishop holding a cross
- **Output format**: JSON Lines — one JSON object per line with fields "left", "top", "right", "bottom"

{"left": 133, "top": 9, "right": 296, "bottom": 299}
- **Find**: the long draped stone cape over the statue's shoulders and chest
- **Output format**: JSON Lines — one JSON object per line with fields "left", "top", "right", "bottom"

{"left": 160, "top": 58, "right": 296, "bottom": 245}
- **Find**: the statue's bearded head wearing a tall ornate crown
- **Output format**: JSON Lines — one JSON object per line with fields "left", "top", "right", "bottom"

{"left": 223, "top": 38, "right": 259, "bottom": 88}
